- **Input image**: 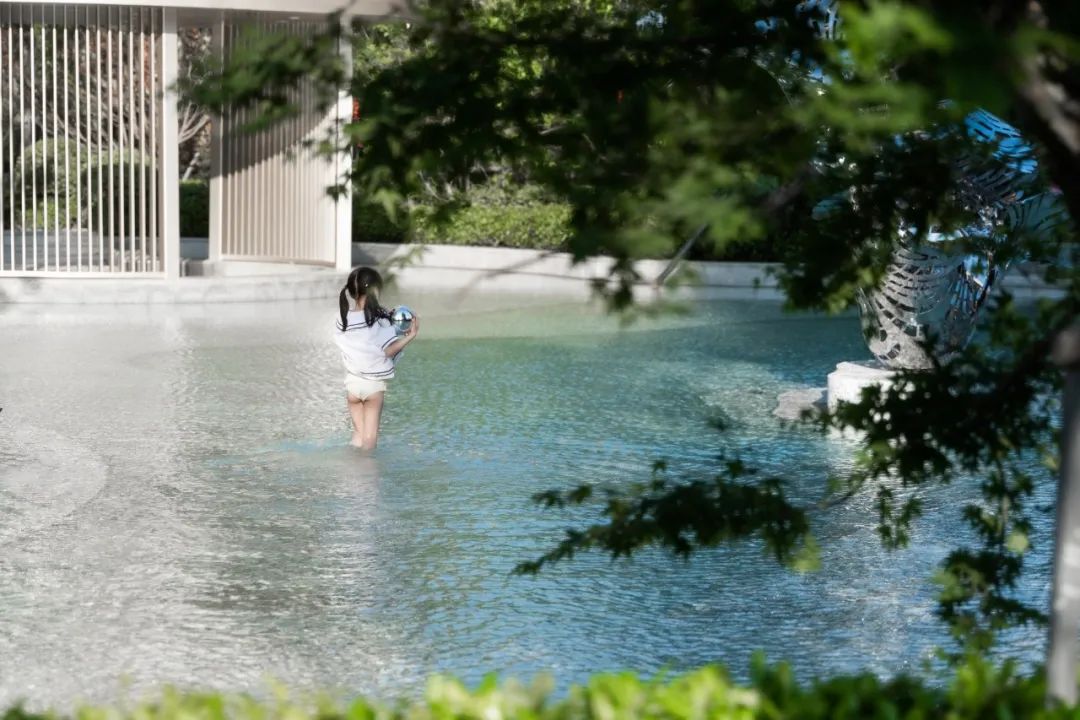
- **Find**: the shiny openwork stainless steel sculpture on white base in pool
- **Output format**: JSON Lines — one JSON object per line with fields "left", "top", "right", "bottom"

{"left": 859, "top": 110, "right": 1066, "bottom": 369}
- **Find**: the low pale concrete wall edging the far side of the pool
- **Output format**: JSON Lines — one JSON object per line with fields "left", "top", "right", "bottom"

{"left": 0, "top": 239, "right": 1062, "bottom": 303}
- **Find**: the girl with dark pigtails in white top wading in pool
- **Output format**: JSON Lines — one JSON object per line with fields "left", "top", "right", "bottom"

{"left": 334, "top": 268, "right": 420, "bottom": 452}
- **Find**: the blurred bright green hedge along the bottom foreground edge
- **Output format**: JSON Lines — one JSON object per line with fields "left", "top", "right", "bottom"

{"left": 2, "top": 661, "right": 1078, "bottom": 720}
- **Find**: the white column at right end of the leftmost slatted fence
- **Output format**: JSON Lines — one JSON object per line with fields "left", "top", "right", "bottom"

{"left": 160, "top": 8, "right": 180, "bottom": 280}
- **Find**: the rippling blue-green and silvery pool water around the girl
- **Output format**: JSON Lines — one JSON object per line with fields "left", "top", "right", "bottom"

{"left": 0, "top": 296, "right": 1050, "bottom": 707}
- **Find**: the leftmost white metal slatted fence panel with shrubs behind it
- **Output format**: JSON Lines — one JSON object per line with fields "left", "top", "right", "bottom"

{"left": 0, "top": 3, "right": 165, "bottom": 275}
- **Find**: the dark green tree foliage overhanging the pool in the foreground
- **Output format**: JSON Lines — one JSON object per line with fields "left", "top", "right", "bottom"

{"left": 187, "top": 0, "right": 1080, "bottom": 660}
